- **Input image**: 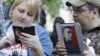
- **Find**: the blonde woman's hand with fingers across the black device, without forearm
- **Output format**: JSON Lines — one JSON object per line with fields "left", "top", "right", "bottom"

{"left": 18, "top": 32, "right": 42, "bottom": 49}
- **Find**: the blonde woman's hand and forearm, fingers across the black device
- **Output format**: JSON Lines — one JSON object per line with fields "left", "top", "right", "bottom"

{"left": 18, "top": 32, "right": 44, "bottom": 56}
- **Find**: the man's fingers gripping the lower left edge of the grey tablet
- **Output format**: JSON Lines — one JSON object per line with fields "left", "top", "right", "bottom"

{"left": 55, "top": 42, "right": 67, "bottom": 56}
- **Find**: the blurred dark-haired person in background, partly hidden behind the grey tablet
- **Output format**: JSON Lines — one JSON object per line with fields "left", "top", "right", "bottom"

{"left": 51, "top": 17, "right": 64, "bottom": 56}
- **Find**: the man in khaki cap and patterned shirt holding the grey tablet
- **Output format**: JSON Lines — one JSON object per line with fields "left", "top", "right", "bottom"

{"left": 56, "top": 0, "right": 100, "bottom": 56}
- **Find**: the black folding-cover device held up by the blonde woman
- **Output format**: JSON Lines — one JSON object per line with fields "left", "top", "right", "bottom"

{"left": 13, "top": 26, "right": 35, "bottom": 43}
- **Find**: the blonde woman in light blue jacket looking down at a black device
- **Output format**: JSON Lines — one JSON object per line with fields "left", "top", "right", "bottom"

{"left": 0, "top": 0, "right": 53, "bottom": 56}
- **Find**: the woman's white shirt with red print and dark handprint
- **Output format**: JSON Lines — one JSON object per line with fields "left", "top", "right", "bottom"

{"left": 0, "top": 26, "right": 27, "bottom": 56}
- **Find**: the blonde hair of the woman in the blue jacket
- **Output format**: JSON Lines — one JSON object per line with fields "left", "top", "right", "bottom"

{"left": 9, "top": 0, "right": 40, "bottom": 23}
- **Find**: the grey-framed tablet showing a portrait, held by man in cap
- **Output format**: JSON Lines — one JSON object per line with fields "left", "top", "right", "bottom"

{"left": 56, "top": 23, "right": 84, "bottom": 56}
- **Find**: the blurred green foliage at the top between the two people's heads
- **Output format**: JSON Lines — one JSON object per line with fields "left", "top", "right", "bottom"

{"left": 46, "top": 0, "right": 60, "bottom": 17}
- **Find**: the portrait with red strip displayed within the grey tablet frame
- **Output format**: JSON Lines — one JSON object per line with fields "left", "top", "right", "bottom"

{"left": 61, "top": 25, "right": 81, "bottom": 54}
